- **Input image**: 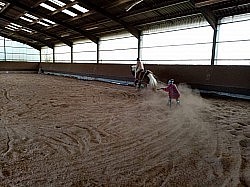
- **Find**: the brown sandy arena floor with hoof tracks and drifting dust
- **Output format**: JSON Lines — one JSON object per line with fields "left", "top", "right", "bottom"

{"left": 0, "top": 74, "right": 250, "bottom": 187}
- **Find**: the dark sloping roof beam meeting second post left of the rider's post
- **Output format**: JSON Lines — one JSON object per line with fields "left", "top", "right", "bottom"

{"left": 0, "top": 14, "right": 73, "bottom": 46}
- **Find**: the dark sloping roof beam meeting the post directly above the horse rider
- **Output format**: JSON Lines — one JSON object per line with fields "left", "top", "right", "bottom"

{"left": 78, "top": 0, "right": 140, "bottom": 38}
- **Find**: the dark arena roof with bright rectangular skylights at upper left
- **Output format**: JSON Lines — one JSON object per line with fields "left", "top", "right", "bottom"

{"left": 0, "top": 0, "right": 250, "bottom": 48}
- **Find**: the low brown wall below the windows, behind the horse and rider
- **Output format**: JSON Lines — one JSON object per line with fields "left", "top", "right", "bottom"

{"left": 0, "top": 62, "right": 250, "bottom": 96}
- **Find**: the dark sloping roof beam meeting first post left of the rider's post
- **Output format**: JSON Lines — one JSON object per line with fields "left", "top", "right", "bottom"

{"left": 6, "top": 0, "right": 99, "bottom": 43}
